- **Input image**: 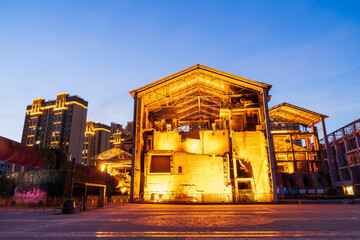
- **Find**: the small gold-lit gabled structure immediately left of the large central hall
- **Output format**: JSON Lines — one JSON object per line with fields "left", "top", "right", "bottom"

{"left": 91, "top": 148, "right": 131, "bottom": 194}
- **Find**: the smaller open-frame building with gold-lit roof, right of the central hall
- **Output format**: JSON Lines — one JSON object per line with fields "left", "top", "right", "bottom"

{"left": 269, "top": 103, "right": 328, "bottom": 197}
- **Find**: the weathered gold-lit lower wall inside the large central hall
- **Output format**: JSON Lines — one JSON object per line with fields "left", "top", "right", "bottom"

{"left": 145, "top": 130, "right": 273, "bottom": 202}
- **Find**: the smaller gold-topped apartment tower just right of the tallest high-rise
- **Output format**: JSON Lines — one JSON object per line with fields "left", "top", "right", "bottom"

{"left": 82, "top": 121, "right": 111, "bottom": 165}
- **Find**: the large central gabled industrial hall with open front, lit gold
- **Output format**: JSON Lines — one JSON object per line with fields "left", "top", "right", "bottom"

{"left": 130, "top": 65, "right": 274, "bottom": 202}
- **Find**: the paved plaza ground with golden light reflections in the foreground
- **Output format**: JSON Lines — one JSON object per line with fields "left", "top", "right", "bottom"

{"left": 0, "top": 204, "right": 360, "bottom": 240}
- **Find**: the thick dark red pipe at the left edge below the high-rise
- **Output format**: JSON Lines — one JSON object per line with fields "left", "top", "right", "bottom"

{"left": 0, "top": 136, "right": 44, "bottom": 168}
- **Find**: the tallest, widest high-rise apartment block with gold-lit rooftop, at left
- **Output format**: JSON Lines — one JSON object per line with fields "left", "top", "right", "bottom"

{"left": 21, "top": 93, "right": 88, "bottom": 163}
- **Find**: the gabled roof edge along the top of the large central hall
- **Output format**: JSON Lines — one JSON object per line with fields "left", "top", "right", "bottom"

{"left": 130, "top": 64, "right": 272, "bottom": 97}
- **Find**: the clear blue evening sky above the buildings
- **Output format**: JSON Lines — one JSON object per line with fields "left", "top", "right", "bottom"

{"left": 0, "top": 0, "right": 360, "bottom": 141}
